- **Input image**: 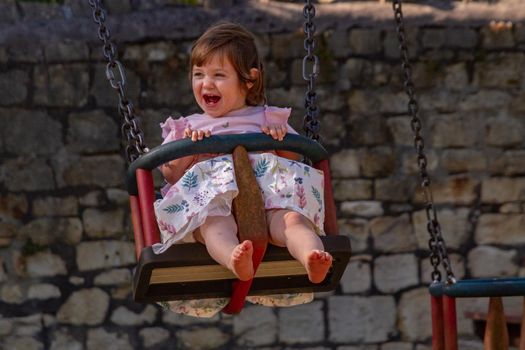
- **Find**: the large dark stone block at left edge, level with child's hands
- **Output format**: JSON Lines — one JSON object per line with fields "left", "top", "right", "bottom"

{"left": 0, "top": 108, "right": 62, "bottom": 155}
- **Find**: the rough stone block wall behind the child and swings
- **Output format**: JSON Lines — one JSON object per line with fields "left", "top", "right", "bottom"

{"left": 0, "top": 0, "right": 525, "bottom": 350}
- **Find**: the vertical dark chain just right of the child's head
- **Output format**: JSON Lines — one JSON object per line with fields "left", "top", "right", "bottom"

{"left": 303, "top": 0, "right": 321, "bottom": 141}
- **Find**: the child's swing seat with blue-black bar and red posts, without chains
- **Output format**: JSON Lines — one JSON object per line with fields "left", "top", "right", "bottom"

{"left": 126, "top": 134, "right": 350, "bottom": 313}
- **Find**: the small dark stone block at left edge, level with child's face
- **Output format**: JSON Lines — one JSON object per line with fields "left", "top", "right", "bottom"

{"left": 0, "top": 69, "right": 29, "bottom": 106}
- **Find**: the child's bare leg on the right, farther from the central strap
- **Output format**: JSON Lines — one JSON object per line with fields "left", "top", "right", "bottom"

{"left": 266, "top": 209, "right": 332, "bottom": 283}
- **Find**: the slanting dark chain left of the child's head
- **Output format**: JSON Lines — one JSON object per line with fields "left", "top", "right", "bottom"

{"left": 88, "top": 0, "right": 148, "bottom": 162}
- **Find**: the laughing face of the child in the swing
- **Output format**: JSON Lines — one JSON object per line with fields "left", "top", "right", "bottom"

{"left": 191, "top": 55, "right": 248, "bottom": 118}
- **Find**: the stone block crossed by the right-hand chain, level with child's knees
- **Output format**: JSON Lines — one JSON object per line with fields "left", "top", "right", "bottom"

{"left": 412, "top": 208, "right": 472, "bottom": 249}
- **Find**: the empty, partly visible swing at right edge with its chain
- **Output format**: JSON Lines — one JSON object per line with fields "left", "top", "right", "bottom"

{"left": 392, "top": 0, "right": 525, "bottom": 350}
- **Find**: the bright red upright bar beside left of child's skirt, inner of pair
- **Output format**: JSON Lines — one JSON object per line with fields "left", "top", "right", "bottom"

{"left": 136, "top": 169, "right": 160, "bottom": 247}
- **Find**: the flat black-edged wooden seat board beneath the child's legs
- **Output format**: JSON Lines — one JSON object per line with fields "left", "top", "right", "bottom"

{"left": 133, "top": 236, "right": 350, "bottom": 302}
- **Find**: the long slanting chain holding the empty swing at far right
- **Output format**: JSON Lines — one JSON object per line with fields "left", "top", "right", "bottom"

{"left": 392, "top": 0, "right": 456, "bottom": 283}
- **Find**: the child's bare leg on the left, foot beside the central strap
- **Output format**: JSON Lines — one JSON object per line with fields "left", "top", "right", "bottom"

{"left": 195, "top": 215, "right": 254, "bottom": 281}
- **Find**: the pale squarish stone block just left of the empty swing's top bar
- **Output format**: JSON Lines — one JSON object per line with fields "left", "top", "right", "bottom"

{"left": 374, "top": 254, "right": 419, "bottom": 293}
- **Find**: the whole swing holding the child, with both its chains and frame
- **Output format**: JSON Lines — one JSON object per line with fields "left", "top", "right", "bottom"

{"left": 88, "top": 0, "right": 350, "bottom": 314}
